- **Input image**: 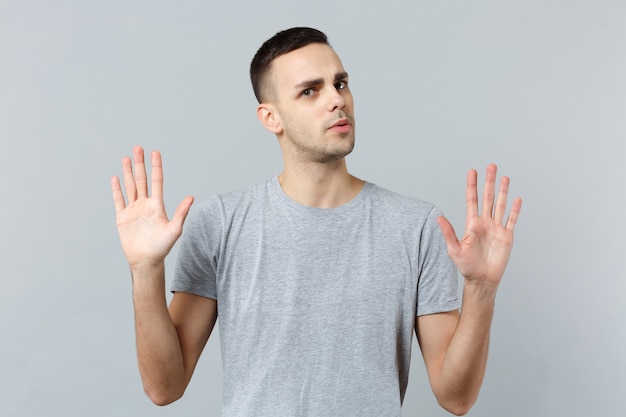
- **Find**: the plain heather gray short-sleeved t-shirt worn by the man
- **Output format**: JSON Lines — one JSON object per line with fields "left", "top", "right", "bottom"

{"left": 172, "top": 177, "right": 460, "bottom": 417}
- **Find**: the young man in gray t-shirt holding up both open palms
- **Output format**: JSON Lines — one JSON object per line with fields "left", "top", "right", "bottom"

{"left": 112, "top": 28, "right": 521, "bottom": 417}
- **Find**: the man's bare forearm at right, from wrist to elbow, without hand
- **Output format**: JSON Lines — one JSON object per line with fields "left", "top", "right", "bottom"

{"left": 436, "top": 283, "right": 496, "bottom": 414}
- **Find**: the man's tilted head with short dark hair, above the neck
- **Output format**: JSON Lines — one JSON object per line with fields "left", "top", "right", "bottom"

{"left": 251, "top": 28, "right": 354, "bottom": 163}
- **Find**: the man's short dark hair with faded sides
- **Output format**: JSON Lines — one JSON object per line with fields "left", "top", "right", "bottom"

{"left": 250, "top": 27, "right": 330, "bottom": 103}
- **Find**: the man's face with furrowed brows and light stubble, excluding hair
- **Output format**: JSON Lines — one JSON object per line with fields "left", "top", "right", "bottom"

{"left": 268, "top": 43, "right": 354, "bottom": 162}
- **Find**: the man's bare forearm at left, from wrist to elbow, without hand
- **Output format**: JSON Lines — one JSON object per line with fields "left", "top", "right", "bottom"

{"left": 131, "top": 264, "right": 186, "bottom": 405}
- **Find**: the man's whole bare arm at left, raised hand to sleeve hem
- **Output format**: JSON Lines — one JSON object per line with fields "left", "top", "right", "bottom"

{"left": 111, "top": 147, "right": 217, "bottom": 405}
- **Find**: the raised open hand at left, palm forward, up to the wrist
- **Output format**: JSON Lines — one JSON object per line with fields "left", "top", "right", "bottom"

{"left": 111, "top": 146, "right": 193, "bottom": 267}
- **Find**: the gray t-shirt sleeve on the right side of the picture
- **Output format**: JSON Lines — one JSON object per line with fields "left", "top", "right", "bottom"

{"left": 416, "top": 207, "right": 461, "bottom": 316}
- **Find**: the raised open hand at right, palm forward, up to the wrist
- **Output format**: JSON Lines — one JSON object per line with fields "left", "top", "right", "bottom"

{"left": 437, "top": 165, "right": 522, "bottom": 287}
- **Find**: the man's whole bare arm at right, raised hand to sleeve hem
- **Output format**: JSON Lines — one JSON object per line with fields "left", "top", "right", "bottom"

{"left": 415, "top": 165, "right": 522, "bottom": 415}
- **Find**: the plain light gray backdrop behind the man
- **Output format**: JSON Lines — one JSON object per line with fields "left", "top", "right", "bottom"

{"left": 0, "top": 0, "right": 626, "bottom": 417}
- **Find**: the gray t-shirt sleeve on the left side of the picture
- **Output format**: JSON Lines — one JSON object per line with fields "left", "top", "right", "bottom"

{"left": 171, "top": 196, "right": 223, "bottom": 300}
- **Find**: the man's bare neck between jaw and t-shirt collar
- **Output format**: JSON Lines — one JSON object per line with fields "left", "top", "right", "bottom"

{"left": 278, "top": 158, "right": 364, "bottom": 208}
